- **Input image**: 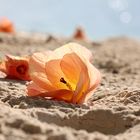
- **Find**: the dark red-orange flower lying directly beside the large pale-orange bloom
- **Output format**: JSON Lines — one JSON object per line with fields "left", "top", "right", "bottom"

{"left": 0, "top": 55, "right": 30, "bottom": 80}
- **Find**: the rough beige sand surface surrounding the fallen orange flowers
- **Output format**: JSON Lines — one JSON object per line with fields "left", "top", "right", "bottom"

{"left": 0, "top": 33, "right": 140, "bottom": 140}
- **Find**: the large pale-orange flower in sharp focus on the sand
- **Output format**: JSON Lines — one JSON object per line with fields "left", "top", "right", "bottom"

{"left": 27, "top": 43, "right": 101, "bottom": 104}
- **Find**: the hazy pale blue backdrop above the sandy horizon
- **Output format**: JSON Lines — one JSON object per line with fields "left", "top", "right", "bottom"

{"left": 0, "top": 0, "right": 140, "bottom": 39}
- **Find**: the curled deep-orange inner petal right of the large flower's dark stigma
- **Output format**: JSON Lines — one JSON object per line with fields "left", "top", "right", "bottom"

{"left": 60, "top": 53, "right": 89, "bottom": 103}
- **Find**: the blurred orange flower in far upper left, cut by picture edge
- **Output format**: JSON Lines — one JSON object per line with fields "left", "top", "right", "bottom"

{"left": 0, "top": 18, "right": 14, "bottom": 33}
